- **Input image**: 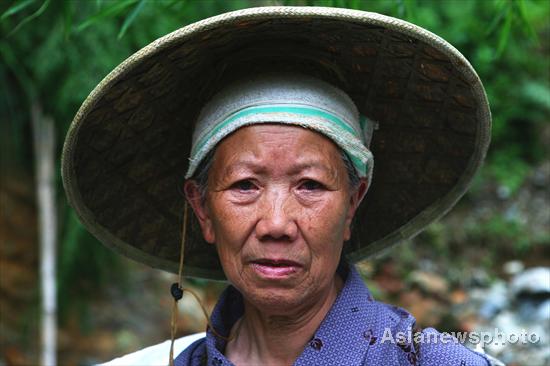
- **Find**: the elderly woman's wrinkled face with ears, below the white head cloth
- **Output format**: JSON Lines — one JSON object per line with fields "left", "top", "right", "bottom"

{"left": 186, "top": 124, "right": 365, "bottom": 314}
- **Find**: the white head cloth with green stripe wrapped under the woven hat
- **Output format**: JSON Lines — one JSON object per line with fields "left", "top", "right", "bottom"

{"left": 185, "top": 73, "right": 374, "bottom": 184}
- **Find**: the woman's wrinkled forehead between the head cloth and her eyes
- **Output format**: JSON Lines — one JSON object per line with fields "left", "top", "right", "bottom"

{"left": 206, "top": 123, "right": 354, "bottom": 186}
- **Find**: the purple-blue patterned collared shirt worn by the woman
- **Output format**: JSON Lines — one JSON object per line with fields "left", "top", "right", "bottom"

{"left": 175, "top": 265, "right": 491, "bottom": 366}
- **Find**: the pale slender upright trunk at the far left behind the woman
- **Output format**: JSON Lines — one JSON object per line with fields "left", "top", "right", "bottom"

{"left": 32, "top": 103, "right": 57, "bottom": 366}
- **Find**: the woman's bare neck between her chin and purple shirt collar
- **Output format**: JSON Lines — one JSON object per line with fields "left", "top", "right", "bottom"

{"left": 225, "top": 276, "right": 343, "bottom": 366}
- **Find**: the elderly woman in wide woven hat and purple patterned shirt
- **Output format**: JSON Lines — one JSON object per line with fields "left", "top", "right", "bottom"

{"left": 63, "top": 7, "right": 502, "bottom": 365}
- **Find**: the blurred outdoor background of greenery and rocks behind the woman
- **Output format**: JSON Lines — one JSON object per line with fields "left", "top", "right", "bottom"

{"left": 0, "top": 0, "right": 550, "bottom": 365}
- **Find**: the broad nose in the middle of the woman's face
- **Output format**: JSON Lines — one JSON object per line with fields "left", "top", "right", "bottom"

{"left": 256, "top": 190, "right": 298, "bottom": 242}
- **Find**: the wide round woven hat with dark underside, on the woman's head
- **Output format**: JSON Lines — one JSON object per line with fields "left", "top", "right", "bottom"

{"left": 62, "top": 7, "right": 491, "bottom": 279}
